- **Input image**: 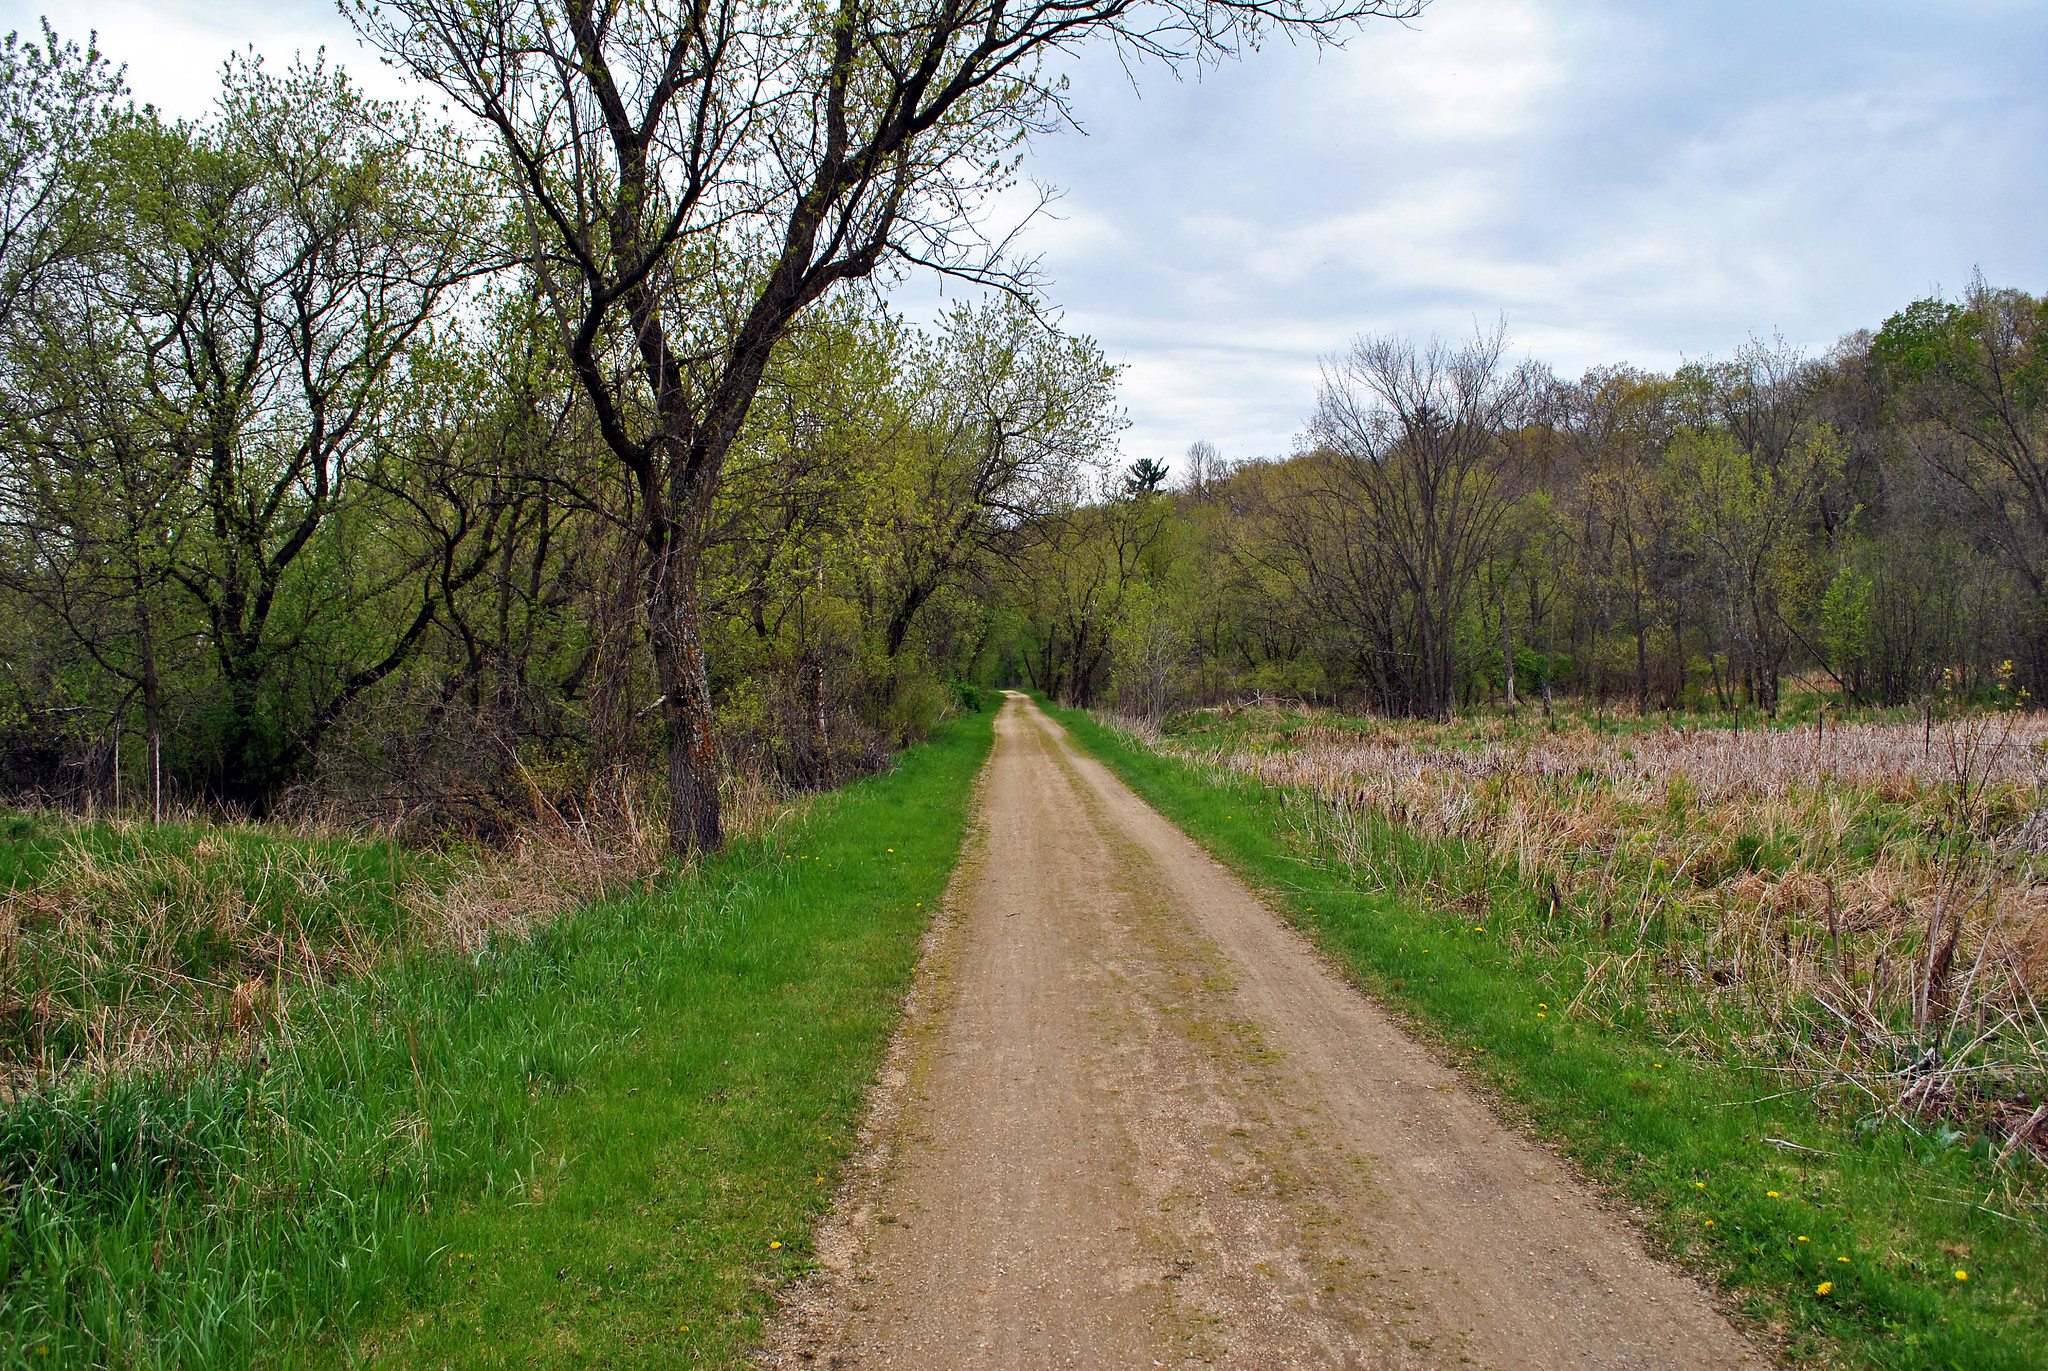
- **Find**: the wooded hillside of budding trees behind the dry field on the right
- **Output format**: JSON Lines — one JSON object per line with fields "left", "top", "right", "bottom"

{"left": 1032, "top": 281, "right": 2048, "bottom": 715}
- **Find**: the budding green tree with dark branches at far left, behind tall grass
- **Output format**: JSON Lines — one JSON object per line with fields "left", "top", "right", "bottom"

{"left": 8, "top": 61, "right": 485, "bottom": 807}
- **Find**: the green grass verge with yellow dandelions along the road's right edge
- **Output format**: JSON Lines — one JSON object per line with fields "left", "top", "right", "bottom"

{"left": 1053, "top": 709, "right": 2048, "bottom": 1369}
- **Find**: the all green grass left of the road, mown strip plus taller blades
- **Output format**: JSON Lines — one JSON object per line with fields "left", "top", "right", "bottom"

{"left": 0, "top": 715, "right": 991, "bottom": 1367}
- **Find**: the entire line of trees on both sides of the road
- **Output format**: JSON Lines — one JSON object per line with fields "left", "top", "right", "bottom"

{"left": 0, "top": 21, "right": 2048, "bottom": 848}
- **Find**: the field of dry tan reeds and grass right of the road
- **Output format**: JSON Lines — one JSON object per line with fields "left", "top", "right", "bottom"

{"left": 1147, "top": 711, "right": 2048, "bottom": 1164}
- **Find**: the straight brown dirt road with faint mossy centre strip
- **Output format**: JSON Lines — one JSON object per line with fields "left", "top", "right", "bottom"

{"left": 762, "top": 695, "right": 1765, "bottom": 1371}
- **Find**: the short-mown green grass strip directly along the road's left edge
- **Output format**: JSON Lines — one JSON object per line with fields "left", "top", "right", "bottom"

{"left": 330, "top": 713, "right": 993, "bottom": 1367}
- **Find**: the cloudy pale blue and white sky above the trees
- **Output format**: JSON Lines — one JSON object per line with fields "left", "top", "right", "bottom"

{"left": 16, "top": 0, "right": 2048, "bottom": 459}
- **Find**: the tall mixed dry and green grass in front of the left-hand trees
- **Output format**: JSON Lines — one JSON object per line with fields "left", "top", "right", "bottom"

{"left": 0, "top": 758, "right": 791, "bottom": 1103}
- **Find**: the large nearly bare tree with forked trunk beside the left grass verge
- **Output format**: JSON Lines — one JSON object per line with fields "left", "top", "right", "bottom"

{"left": 352, "top": 0, "right": 1423, "bottom": 853}
